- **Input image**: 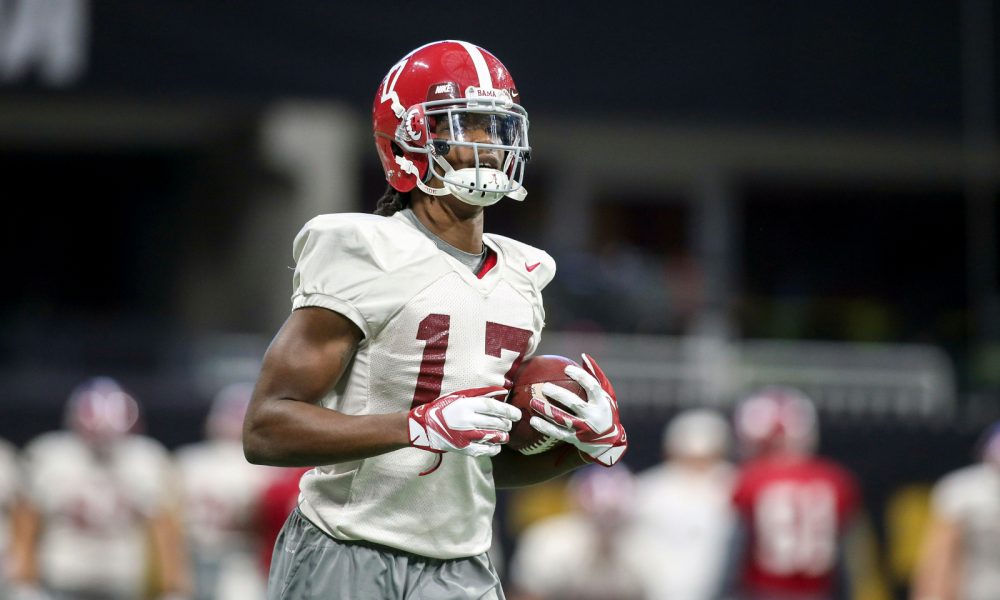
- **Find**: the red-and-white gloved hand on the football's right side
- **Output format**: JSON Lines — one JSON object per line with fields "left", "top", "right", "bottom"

{"left": 529, "top": 354, "right": 628, "bottom": 467}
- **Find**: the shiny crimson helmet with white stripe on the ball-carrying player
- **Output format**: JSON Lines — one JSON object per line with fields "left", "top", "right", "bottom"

{"left": 372, "top": 40, "right": 531, "bottom": 206}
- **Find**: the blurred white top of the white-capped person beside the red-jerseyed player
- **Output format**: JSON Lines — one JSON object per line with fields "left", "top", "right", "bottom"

{"left": 635, "top": 463, "right": 735, "bottom": 600}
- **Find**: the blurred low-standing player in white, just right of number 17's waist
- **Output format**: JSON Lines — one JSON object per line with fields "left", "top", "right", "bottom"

{"left": 510, "top": 465, "right": 648, "bottom": 600}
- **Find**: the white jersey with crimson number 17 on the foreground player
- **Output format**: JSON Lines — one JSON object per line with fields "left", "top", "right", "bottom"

{"left": 292, "top": 214, "right": 555, "bottom": 558}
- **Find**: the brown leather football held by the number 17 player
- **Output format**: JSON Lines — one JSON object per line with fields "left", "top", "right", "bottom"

{"left": 507, "top": 354, "right": 587, "bottom": 454}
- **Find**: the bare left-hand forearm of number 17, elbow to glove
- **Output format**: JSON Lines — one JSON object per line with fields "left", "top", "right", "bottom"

{"left": 243, "top": 399, "right": 410, "bottom": 467}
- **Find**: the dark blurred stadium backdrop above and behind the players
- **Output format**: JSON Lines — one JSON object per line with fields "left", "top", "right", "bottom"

{"left": 0, "top": 0, "right": 1000, "bottom": 589}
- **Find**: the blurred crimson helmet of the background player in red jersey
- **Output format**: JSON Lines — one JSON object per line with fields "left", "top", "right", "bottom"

{"left": 735, "top": 386, "right": 819, "bottom": 455}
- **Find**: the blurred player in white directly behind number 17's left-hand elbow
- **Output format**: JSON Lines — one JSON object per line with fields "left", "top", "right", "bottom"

{"left": 175, "top": 383, "right": 272, "bottom": 600}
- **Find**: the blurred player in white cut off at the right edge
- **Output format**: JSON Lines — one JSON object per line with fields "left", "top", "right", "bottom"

{"left": 911, "top": 422, "right": 1000, "bottom": 600}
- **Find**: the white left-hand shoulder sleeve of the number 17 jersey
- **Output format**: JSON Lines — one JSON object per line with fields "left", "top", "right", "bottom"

{"left": 292, "top": 214, "right": 418, "bottom": 338}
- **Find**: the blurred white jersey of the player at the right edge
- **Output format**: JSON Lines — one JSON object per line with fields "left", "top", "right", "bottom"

{"left": 931, "top": 463, "right": 1000, "bottom": 600}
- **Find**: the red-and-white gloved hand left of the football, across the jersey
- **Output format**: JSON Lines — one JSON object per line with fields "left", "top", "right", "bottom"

{"left": 409, "top": 386, "right": 521, "bottom": 456}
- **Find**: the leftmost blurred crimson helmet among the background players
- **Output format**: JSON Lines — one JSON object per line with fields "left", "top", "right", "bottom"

{"left": 66, "top": 377, "right": 139, "bottom": 444}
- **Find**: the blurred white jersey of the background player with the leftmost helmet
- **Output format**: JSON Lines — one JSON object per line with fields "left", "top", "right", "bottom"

{"left": 25, "top": 432, "right": 170, "bottom": 597}
